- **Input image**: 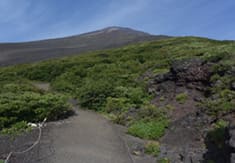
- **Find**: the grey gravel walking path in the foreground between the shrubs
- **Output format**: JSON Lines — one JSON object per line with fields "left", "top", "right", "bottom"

{"left": 41, "top": 110, "right": 132, "bottom": 163}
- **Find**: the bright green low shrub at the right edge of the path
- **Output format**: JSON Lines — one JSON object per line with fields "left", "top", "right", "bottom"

{"left": 128, "top": 120, "right": 168, "bottom": 140}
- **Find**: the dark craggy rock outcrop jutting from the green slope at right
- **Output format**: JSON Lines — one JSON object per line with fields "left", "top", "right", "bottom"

{"left": 148, "top": 59, "right": 211, "bottom": 94}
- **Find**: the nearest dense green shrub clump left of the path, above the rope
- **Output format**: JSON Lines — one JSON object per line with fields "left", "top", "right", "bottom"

{"left": 0, "top": 92, "right": 69, "bottom": 129}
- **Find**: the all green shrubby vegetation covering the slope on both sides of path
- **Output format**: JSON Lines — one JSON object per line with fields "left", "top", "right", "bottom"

{"left": 0, "top": 37, "right": 235, "bottom": 141}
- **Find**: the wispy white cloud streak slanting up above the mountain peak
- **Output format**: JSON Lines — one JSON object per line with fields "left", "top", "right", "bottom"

{"left": 26, "top": 0, "right": 152, "bottom": 39}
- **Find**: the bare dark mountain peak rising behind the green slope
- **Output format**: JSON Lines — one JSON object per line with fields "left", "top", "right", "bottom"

{"left": 0, "top": 27, "right": 168, "bottom": 66}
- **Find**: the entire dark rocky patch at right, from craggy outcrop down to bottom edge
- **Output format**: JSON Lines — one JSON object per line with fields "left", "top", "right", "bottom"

{"left": 148, "top": 59, "right": 235, "bottom": 163}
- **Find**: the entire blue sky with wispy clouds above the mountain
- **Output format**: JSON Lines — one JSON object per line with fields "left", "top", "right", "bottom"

{"left": 0, "top": 0, "right": 235, "bottom": 42}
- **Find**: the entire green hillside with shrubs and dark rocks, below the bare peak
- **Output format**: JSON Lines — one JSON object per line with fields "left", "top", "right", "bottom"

{"left": 0, "top": 37, "right": 235, "bottom": 163}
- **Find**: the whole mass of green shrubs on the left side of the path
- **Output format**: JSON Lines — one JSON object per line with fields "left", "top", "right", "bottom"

{"left": 0, "top": 69, "right": 70, "bottom": 133}
